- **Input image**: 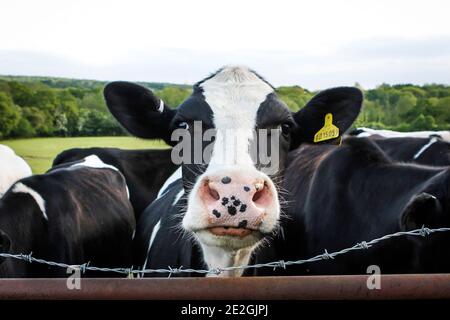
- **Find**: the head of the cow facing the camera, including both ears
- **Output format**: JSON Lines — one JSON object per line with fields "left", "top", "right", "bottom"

{"left": 105, "top": 67, "right": 362, "bottom": 276}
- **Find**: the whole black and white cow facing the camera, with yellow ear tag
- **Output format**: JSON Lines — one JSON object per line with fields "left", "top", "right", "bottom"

{"left": 105, "top": 67, "right": 362, "bottom": 276}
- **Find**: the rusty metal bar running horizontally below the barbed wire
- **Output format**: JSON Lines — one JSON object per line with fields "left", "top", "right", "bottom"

{"left": 0, "top": 274, "right": 450, "bottom": 300}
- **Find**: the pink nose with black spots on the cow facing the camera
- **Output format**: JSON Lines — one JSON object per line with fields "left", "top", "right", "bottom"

{"left": 199, "top": 176, "right": 274, "bottom": 236}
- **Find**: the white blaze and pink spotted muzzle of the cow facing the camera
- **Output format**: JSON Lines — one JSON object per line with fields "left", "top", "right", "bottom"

{"left": 183, "top": 67, "right": 280, "bottom": 251}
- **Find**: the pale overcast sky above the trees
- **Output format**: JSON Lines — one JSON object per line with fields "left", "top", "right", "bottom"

{"left": 0, "top": 0, "right": 450, "bottom": 89}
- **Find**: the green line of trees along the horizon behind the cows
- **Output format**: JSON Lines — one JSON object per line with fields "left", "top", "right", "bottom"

{"left": 0, "top": 76, "right": 450, "bottom": 139}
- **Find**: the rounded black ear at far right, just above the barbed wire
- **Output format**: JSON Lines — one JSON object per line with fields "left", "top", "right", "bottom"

{"left": 400, "top": 192, "right": 442, "bottom": 231}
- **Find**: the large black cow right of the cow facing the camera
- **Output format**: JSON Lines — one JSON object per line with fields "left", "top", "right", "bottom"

{"left": 264, "top": 138, "right": 450, "bottom": 275}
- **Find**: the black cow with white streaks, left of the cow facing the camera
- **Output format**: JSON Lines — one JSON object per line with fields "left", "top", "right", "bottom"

{"left": 0, "top": 156, "right": 136, "bottom": 278}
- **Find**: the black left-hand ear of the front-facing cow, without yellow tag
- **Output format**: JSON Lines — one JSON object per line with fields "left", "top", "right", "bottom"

{"left": 103, "top": 81, "right": 176, "bottom": 143}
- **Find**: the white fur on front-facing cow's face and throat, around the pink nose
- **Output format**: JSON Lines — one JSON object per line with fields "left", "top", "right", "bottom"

{"left": 182, "top": 67, "right": 280, "bottom": 275}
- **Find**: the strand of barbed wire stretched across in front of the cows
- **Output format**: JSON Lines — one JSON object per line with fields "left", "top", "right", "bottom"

{"left": 0, "top": 226, "right": 450, "bottom": 277}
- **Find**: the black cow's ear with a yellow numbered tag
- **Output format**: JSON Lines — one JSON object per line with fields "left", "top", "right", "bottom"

{"left": 291, "top": 87, "right": 363, "bottom": 147}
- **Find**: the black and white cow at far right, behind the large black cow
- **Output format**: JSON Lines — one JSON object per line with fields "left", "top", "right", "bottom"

{"left": 350, "top": 128, "right": 450, "bottom": 166}
